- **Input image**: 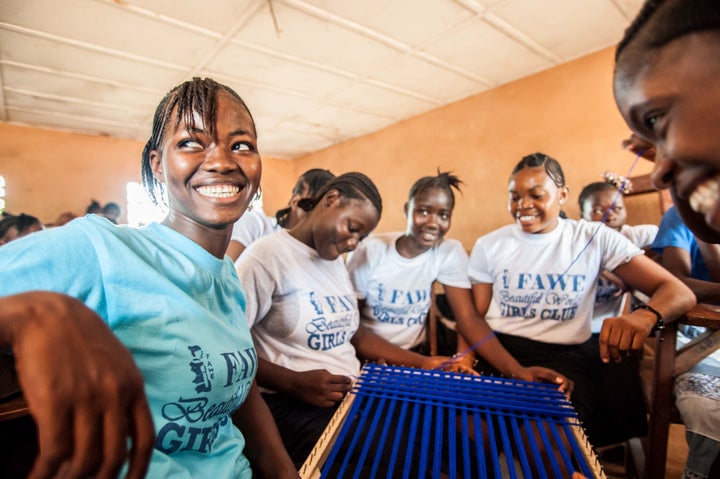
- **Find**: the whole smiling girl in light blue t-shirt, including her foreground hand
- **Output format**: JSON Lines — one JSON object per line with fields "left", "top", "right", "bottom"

{"left": 0, "top": 78, "right": 298, "bottom": 479}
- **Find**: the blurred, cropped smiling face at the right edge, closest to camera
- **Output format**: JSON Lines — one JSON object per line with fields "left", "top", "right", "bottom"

{"left": 614, "top": 32, "right": 720, "bottom": 242}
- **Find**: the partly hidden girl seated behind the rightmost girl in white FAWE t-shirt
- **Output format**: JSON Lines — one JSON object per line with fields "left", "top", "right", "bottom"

{"left": 578, "top": 178, "right": 658, "bottom": 447}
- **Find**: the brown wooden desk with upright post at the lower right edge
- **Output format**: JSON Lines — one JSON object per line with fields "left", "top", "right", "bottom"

{"left": 643, "top": 304, "right": 720, "bottom": 479}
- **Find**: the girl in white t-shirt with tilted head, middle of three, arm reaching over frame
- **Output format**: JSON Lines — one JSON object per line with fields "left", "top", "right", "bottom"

{"left": 347, "top": 172, "right": 572, "bottom": 392}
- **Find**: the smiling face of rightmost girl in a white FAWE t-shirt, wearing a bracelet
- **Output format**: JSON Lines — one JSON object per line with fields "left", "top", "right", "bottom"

{"left": 508, "top": 166, "right": 568, "bottom": 234}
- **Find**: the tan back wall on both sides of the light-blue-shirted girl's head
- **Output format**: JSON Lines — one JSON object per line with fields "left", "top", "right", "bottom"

{"left": 0, "top": 123, "right": 296, "bottom": 223}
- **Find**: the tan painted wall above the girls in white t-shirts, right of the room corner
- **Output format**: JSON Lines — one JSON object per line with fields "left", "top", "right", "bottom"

{"left": 297, "top": 49, "right": 650, "bottom": 249}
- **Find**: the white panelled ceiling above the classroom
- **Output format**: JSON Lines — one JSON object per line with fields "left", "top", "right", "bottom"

{"left": 0, "top": 0, "right": 642, "bottom": 158}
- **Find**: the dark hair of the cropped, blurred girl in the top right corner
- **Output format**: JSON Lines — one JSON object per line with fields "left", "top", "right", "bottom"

{"left": 615, "top": 0, "right": 720, "bottom": 63}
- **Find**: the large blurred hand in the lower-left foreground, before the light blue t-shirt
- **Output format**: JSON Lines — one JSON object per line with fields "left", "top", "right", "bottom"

{"left": 0, "top": 292, "right": 155, "bottom": 478}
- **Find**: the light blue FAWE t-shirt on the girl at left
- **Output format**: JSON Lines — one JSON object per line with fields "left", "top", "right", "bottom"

{"left": 0, "top": 215, "right": 257, "bottom": 478}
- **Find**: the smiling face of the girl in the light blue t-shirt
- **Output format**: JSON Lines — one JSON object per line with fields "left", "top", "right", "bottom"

{"left": 150, "top": 90, "right": 262, "bottom": 244}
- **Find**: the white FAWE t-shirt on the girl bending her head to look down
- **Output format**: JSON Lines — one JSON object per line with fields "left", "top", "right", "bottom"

{"left": 235, "top": 230, "right": 360, "bottom": 382}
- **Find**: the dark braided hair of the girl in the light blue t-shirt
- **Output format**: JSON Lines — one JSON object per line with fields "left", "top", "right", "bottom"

{"left": 141, "top": 77, "right": 257, "bottom": 205}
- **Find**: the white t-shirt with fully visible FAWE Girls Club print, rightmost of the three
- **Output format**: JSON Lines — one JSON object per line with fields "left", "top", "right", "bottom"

{"left": 468, "top": 218, "right": 643, "bottom": 344}
